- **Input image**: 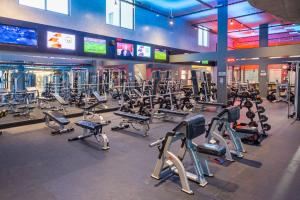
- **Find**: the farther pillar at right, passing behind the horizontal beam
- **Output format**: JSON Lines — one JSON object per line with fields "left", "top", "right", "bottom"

{"left": 258, "top": 24, "right": 269, "bottom": 97}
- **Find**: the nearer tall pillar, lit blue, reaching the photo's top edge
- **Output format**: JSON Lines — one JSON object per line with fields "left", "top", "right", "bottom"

{"left": 217, "top": 0, "right": 228, "bottom": 104}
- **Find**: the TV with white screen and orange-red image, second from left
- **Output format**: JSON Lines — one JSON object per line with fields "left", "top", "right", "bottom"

{"left": 47, "top": 31, "right": 76, "bottom": 50}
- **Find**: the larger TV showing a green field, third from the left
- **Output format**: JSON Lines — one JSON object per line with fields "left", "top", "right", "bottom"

{"left": 84, "top": 37, "right": 106, "bottom": 55}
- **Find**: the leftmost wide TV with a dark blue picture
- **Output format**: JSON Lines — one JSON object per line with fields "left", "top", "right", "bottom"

{"left": 0, "top": 24, "right": 37, "bottom": 46}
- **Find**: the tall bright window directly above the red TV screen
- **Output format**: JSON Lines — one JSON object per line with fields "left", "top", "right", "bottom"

{"left": 106, "top": 0, "right": 134, "bottom": 29}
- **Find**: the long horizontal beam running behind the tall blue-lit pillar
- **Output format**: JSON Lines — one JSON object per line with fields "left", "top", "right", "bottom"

{"left": 170, "top": 44, "right": 300, "bottom": 63}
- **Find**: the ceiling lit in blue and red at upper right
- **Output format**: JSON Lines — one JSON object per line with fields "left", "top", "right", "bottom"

{"left": 136, "top": 0, "right": 300, "bottom": 48}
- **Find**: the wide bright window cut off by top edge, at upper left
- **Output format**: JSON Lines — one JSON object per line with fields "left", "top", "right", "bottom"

{"left": 19, "top": 0, "right": 70, "bottom": 15}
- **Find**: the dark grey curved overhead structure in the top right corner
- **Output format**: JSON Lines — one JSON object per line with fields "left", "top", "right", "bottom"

{"left": 249, "top": 0, "right": 300, "bottom": 23}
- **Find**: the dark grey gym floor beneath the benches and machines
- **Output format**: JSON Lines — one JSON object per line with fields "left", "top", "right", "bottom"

{"left": 0, "top": 103, "right": 300, "bottom": 200}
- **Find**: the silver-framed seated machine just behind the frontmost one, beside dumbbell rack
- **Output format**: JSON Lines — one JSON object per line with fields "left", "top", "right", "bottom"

{"left": 206, "top": 106, "right": 259, "bottom": 161}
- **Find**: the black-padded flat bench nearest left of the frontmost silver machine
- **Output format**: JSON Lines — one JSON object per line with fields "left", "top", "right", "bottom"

{"left": 111, "top": 111, "right": 150, "bottom": 136}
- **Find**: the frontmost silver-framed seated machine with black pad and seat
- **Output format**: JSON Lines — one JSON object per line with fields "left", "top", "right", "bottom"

{"left": 150, "top": 115, "right": 226, "bottom": 194}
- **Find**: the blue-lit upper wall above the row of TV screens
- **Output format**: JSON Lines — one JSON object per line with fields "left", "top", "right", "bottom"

{"left": 0, "top": 0, "right": 215, "bottom": 52}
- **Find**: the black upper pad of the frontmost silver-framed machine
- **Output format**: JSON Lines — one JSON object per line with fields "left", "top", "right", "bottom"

{"left": 173, "top": 115, "right": 205, "bottom": 140}
